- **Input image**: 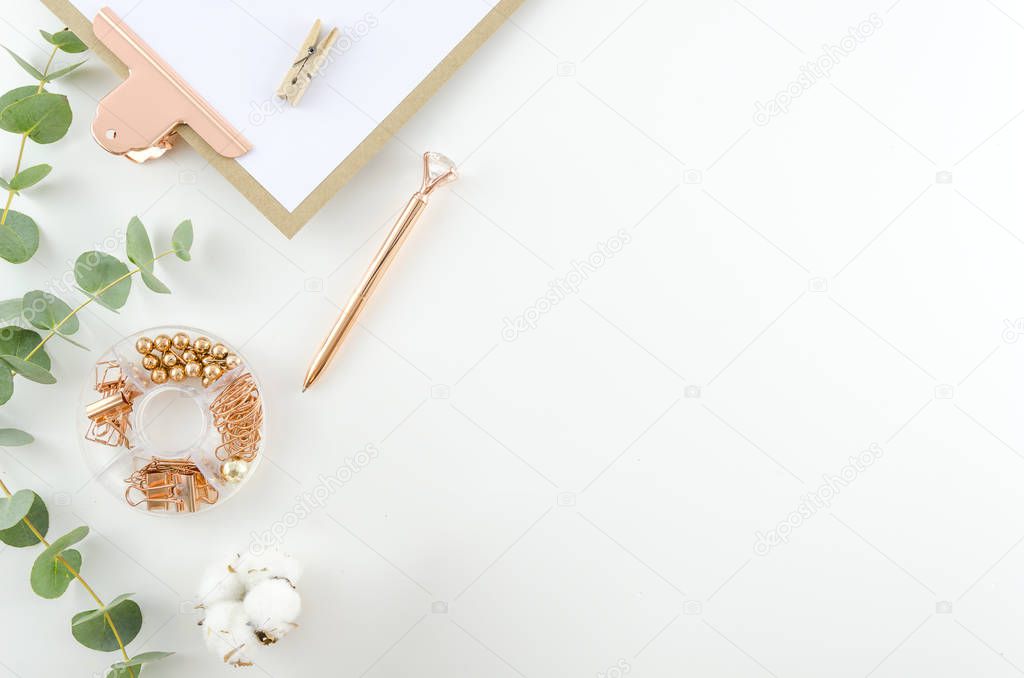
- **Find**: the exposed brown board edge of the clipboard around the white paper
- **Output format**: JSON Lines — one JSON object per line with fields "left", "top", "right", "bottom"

{"left": 42, "top": 0, "right": 524, "bottom": 238}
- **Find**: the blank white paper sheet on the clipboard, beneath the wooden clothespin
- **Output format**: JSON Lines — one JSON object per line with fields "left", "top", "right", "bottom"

{"left": 73, "top": 0, "right": 496, "bottom": 211}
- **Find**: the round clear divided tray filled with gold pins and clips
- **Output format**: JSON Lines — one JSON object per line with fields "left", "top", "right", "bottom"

{"left": 77, "top": 326, "right": 265, "bottom": 514}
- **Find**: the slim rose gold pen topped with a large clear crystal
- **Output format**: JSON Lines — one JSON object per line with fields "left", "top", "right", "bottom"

{"left": 302, "top": 153, "right": 458, "bottom": 391}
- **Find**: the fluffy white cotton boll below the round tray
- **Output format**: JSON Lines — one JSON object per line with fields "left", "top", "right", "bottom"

{"left": 198, "top": 551, "right": 302, "bottom": 666}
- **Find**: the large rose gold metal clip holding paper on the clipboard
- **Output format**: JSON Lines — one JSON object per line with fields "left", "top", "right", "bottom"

{"left": 92, "top": 7, "right": 252, "bottom": 163}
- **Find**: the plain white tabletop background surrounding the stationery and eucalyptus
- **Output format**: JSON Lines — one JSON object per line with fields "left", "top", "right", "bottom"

{"left": 0, "top": 0, "right": 1024, "bottom": 678}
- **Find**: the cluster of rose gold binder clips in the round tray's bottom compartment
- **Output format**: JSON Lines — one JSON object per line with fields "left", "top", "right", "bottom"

{"left": 125, "top": 457, "right": 219, "bottom": 513}
